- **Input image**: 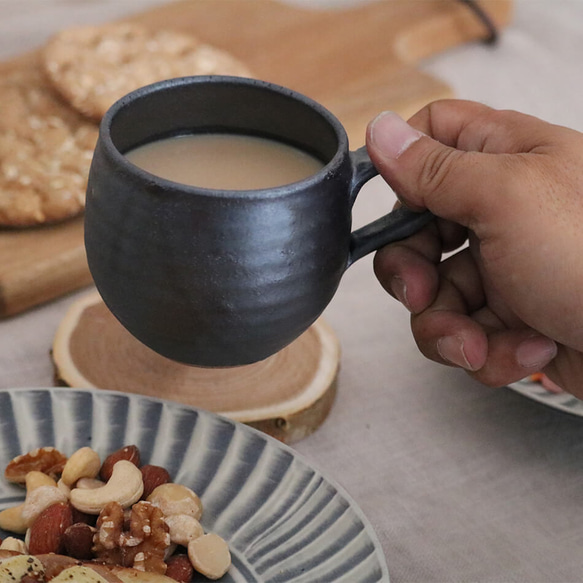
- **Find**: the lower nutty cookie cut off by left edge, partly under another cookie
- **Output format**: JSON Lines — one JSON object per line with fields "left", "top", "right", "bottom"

{"left": 0, "top": 66, "right": 98, "bottom": 227}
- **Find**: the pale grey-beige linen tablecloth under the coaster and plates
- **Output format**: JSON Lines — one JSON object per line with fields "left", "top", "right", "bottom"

{"left": 0, "top": 0, "right": 583, "bottom": 583}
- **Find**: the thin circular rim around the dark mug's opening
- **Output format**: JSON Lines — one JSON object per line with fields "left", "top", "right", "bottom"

{"left": 99, "top": 75, "right": 349, "bottom": 198}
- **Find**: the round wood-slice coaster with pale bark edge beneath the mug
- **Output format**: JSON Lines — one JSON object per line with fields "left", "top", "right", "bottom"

{"left": 52, "top": 292, "right": 340, "bottom": 443}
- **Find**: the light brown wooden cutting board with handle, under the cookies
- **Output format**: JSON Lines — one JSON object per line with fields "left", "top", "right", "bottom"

{"left": 0, "top": 0, "right": 512, "bottom": 317}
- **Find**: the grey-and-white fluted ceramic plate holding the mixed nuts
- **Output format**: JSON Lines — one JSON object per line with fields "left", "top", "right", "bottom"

{"left": 0, "top": 388, "right": 389, "bottom": 583}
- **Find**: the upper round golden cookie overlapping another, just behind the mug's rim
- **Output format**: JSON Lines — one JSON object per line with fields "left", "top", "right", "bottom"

{"left": 43, "top": 23, "right": 249, "bottom": 120}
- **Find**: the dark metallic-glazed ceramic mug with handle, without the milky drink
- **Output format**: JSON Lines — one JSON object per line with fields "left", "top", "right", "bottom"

{"left": 85, "top": 76, "right": 431, "bottom": 366}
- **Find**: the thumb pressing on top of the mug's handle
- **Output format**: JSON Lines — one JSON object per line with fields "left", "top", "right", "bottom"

{"left": 367, "top": 112, "right": 515, "bottom": 227}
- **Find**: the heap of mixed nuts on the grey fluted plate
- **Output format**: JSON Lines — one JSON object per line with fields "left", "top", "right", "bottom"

{"left": 0, "top": 445, "right": 231, "bottom": 583}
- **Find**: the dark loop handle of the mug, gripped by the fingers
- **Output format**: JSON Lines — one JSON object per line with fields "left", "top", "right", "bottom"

{"left": 346, "top": 146, "right": 434, "bottom": 267}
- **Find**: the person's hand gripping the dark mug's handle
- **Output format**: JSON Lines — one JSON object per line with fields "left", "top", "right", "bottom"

{"left": 367, "top": 100, "right": 583, "bottom": 398}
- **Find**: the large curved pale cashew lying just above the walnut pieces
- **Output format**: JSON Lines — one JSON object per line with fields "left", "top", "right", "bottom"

{"left": 71, "top": 460, "right": 144, "bottom": 514}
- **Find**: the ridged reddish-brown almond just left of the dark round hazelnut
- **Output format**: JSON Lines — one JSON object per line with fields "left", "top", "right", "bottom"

{"left": 28, "top": 503, "right": 73, "bottom": 555}
